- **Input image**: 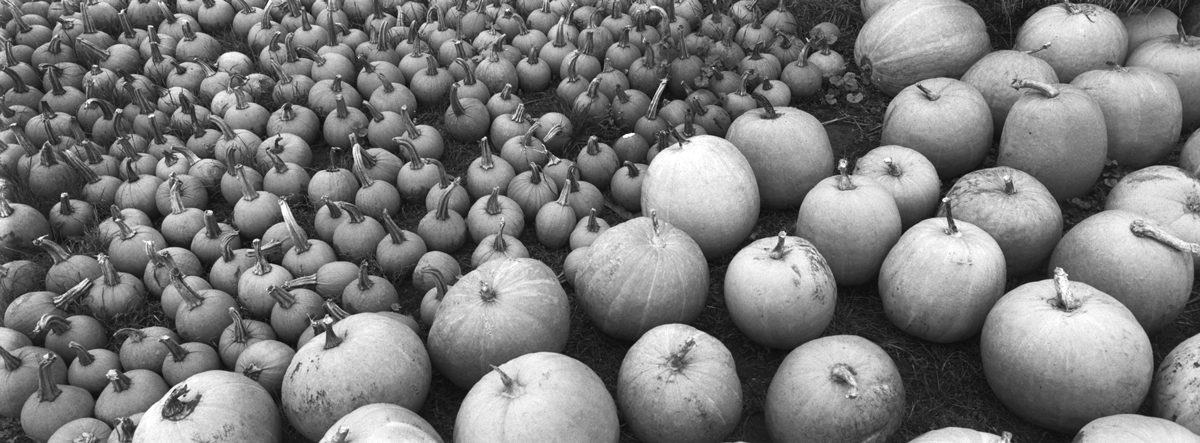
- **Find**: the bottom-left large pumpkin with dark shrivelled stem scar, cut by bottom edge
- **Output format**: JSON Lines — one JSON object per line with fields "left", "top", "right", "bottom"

{"left": 133, "top": 371, "right": 283, "bottom": 443}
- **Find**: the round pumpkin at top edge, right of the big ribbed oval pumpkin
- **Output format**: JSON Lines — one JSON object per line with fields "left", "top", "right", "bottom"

{"left": 1013, "top": 0, "right": 1129, "bottom": 83}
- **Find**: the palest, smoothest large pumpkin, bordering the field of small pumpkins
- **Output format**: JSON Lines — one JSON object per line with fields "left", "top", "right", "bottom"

{"left": 642, "top": 136, "right": 758, "bottom": 258}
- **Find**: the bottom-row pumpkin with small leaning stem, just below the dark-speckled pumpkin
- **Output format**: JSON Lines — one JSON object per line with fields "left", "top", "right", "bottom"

{"left": 617, "top": 323, "right": 742, "bottom": 443}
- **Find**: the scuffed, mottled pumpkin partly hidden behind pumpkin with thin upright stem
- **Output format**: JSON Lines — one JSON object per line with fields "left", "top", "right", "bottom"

{"left": 937, "top": 167, "right": 1062, "bottom": 276}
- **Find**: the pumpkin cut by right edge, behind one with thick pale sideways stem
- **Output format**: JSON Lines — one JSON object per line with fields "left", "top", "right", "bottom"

{"left": 1104, "top": 166, "right": 1200, "bottom": 243}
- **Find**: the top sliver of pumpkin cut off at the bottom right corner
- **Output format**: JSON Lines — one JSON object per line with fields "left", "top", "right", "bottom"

{"left": 1070, "top": 414, "right": 1200, "bottom": 443}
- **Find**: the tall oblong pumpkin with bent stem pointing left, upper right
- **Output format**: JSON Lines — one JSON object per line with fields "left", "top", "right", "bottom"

{"left": 996, "top": 83, "right": 1109, "bottom": 202}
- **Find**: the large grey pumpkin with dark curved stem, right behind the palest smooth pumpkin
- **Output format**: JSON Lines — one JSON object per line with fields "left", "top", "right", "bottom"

{"left": 725, "top": 95, "right": 833, "bottom": 209}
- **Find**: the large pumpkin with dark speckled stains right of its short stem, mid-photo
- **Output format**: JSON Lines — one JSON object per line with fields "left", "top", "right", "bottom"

{"left": 724, "top": 232, "right": 838, "bottom": 349}
